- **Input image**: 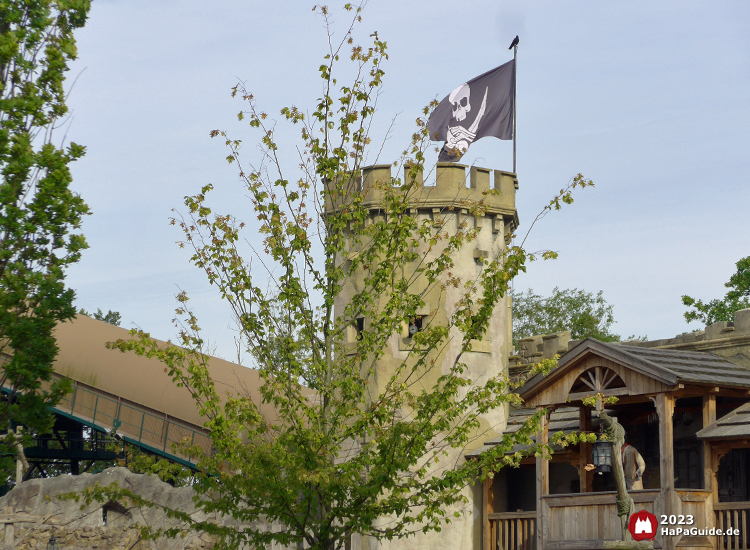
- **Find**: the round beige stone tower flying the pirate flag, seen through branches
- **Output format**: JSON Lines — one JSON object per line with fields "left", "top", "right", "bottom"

{"left": 326, "top": 163, "right": 518, "bottom": 550}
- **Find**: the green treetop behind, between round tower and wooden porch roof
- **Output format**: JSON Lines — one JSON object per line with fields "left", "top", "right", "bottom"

{"left": 511, "top": 287, "right": 620, "bottom": 347}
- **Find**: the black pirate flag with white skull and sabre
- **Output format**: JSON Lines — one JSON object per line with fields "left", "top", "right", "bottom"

{"left": 427, "top": 61, "right": 516, "bottom": 162}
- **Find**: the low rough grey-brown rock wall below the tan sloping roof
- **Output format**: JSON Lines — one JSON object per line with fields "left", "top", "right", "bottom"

{"left": 0, "top": 468, "right": 271, "bottom": 550}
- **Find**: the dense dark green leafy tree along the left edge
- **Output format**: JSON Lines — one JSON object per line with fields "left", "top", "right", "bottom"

{"left": 0, "top": 0, "right": 89, "bottom": 478}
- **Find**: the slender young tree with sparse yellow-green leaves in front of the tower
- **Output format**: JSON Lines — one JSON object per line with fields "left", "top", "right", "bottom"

{"left": 98, "top": 6, "right": 590, "bottom": 550}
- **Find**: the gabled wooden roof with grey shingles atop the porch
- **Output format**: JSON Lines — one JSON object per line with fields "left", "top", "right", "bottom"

{"left": 519, "top": 338, "right": 750, "bottom": 407}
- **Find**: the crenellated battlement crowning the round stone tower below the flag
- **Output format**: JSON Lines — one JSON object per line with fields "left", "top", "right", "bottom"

{"left": 325, "top": 162, "right": 518, "bottom": 228}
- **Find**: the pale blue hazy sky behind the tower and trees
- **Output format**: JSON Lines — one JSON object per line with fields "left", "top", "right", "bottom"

{"left": 66, "top": 0, "right": 750, "bottom": 360}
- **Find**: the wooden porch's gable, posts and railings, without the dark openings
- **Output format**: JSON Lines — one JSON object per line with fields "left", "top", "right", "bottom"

{"left": 476, "top": 342, "right": 750, "bottom": 550}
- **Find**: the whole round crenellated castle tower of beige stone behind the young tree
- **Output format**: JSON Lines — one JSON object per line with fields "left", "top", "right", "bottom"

{"left": 326, "top": 163, "right": 518, "bottom": 550}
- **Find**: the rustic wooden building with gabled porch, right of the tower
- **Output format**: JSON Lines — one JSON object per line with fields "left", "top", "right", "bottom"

{"left": 472, "top": 339, "right": 750, "bottom": 550}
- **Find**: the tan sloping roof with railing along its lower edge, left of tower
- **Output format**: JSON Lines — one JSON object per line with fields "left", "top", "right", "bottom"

{"left": 0, "top": 315, "right": 314, "bottom": 465}
